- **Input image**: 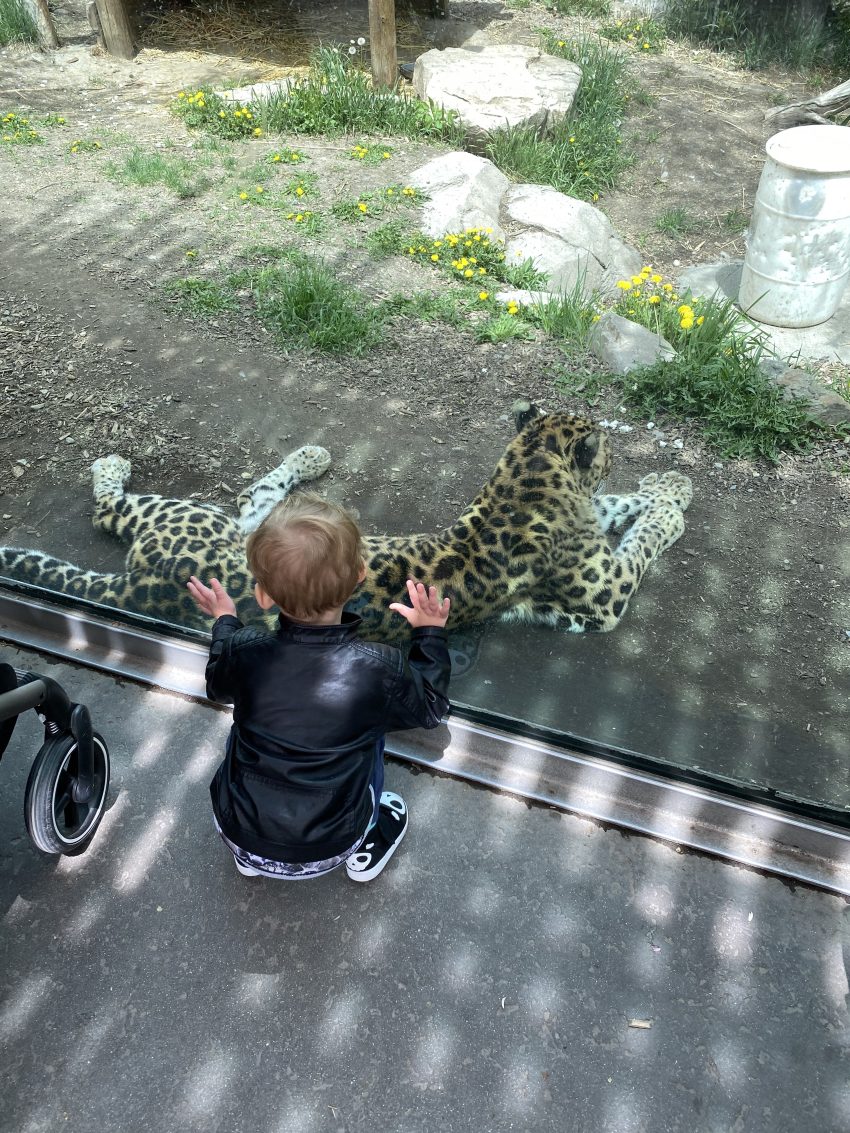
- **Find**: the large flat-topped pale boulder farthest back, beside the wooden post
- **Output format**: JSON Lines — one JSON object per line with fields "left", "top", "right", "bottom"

{"left": 414, "top": 43, "right": 581, "bottom": 144}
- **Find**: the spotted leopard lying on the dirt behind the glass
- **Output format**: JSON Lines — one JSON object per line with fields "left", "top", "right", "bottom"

{"left": 0, "top": 401, "right": 692, "bottom": 641}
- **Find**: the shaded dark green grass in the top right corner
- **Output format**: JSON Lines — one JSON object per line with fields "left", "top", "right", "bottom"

{"left": 663, "top": 0, "right": 850, "bottom": 77}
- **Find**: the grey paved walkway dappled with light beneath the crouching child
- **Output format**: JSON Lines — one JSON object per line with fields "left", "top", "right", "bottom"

{"left": 0, "top": 647, "right": 850, "bottom": 1133}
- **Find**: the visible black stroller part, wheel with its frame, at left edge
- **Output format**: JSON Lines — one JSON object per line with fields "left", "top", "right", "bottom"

{"left": 0, "top": 662, "right": 110, "bottom": 854}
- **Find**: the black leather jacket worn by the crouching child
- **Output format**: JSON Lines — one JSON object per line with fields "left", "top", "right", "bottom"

{"left": 206, "top": 613, "right": 451, "bottom": 862}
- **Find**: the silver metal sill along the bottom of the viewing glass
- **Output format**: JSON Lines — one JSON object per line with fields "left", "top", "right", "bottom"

{"left": 0, "top": 590, "right": 850, "bottom": 896}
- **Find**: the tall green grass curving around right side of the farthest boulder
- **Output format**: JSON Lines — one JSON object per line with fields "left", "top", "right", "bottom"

{"left": 486, "top": 32, "right": 637, "bottom": 201}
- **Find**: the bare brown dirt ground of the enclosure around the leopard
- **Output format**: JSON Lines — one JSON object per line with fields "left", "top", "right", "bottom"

{"left": 0, "top": 2, "right": 850, "bottom": 804}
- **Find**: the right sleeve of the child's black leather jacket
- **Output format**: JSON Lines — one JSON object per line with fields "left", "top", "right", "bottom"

{"left": 386, "top": 625, "right": 451, "bottom": 732}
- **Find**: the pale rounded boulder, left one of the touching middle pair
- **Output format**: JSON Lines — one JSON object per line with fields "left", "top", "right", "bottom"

{"left": 408, "top": 152, "right": 510, "bottom": 240}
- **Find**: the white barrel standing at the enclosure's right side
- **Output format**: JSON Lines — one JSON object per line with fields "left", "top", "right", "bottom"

{"left": 738, "top": 126, "right": 850, "bottom": 326}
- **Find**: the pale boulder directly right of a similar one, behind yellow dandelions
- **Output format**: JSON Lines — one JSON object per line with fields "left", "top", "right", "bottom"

{"left": 502, "top": 185, "right": 643, "bottom": 295}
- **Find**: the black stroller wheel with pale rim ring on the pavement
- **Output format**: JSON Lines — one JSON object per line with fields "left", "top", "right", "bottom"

{"left": 24, "top": 732, "right": 109, "bottom": 854}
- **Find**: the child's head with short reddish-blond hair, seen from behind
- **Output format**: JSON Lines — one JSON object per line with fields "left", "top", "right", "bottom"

{"left": 246, "top": 492, "right": 365, "bottom": 621}
